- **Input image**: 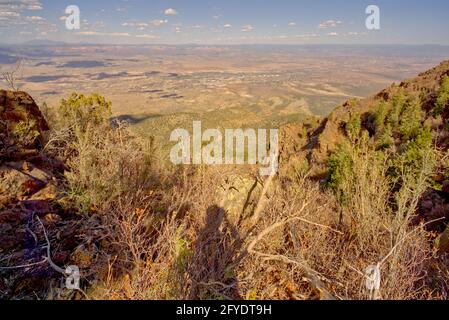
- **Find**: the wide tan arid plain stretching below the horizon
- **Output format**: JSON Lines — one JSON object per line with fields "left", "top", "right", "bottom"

{"left": 0, "top": 43, "right": 449, "bottom": 151}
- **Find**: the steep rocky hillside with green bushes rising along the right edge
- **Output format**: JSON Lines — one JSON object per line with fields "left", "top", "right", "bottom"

{"left": 281, "top": 61, "right": 449, "bottom": 248}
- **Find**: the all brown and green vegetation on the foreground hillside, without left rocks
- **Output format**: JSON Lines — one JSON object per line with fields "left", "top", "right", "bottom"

{"left": 0, "top": 62, "right": 449, "bottom": 299}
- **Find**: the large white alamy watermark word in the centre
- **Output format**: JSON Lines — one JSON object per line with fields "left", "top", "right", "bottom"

{"left": 170, "top": 121, "right": 279, "bottom": 176}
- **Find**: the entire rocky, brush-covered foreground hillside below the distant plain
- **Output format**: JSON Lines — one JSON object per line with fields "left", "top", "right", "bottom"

{"left": 0, "top": 61, "right": 449, "bottom": 300}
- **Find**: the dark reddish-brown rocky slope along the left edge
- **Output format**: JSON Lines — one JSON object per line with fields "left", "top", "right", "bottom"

{"left": 0, "top": 90, "right": 100, "bottom": 300}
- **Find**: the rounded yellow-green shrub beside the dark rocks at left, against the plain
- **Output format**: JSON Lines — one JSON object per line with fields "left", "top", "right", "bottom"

{"left": 66, "top": 126, "right": 158, "bottom": 210}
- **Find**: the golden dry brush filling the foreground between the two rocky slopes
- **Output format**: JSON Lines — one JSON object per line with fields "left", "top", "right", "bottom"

{"left": 41, "top": 102, "right": 447, "bottom": 299}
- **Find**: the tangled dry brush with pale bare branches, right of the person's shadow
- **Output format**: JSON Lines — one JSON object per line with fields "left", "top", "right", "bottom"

{"left": 240, "top": 136, "right": 438, "bottom": 299}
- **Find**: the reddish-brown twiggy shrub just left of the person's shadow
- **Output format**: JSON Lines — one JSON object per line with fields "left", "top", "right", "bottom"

{"left": 88, "top": 193, "right": 184, "bottom": 300}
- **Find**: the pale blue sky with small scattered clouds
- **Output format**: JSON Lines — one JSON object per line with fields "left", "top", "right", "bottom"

{"left": 0, "top": 0, "right": 449, "bottom": 45}
